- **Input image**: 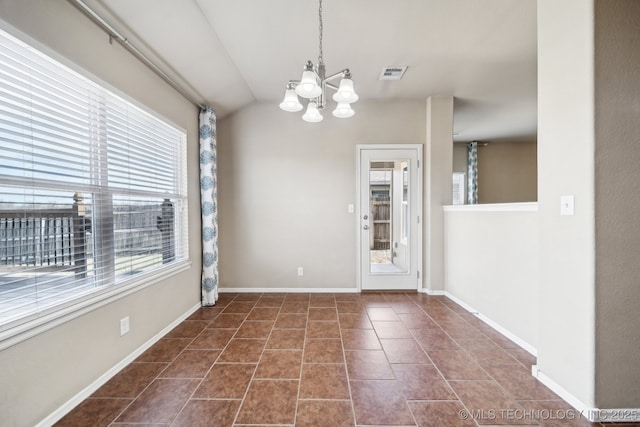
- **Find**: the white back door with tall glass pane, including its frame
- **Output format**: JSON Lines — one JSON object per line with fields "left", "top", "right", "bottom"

{"left": 357, "top": 145, "right": 422, "bottom": 290}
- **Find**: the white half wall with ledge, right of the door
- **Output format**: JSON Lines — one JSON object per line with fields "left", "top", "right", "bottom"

{"left": 444, "top": 203, "right": 539, "bottom": 351}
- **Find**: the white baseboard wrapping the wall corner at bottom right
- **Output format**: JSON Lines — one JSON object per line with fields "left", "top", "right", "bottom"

{"left": 531, "top": 365, "right": 640, "bottom": 423}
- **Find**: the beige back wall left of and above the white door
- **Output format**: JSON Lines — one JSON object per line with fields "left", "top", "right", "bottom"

{"left": 218, "top": 101, "right": 426, "bottom": 290}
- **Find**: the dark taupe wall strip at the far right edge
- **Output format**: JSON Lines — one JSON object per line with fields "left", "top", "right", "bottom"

{"left": 595, "top": 0, "right": 640, "bottom": 408}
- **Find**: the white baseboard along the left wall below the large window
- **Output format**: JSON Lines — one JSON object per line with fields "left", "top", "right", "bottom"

{"left": 36, "top": 303, "right": 201, "bottom": 427}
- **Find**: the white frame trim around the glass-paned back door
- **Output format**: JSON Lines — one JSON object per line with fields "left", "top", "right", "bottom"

{"left": 356, "top": 144, "right": 424, "bottom": 292}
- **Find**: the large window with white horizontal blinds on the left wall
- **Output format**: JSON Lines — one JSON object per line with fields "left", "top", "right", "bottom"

{"left": 0, "top": 32, "right": 188, "bottom": 330}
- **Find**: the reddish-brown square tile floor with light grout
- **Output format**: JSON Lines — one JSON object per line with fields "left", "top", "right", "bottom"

{"left": 53, "top": 293, "right": 594, "bottom": 427}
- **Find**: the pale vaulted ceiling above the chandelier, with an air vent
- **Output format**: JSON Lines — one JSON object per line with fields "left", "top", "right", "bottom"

{"left": 85, "top": 0, "right": 537, "bottom": 141}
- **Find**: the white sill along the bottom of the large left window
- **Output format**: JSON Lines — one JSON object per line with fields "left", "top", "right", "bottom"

{"left": 0, "top": 260, "right": 191, "bottom": 351}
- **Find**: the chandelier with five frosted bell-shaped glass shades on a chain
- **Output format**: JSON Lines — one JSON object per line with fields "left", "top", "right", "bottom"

{"left": 280, "top": 0, "right": 358, "bottom": 123}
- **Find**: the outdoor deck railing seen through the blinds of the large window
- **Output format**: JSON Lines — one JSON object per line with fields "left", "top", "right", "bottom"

{"left": 0, "top": 198, "right": 175, "bottom": 277}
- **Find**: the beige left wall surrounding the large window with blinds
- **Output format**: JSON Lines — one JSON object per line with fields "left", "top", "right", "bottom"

{"left": 0, "top": 0, "right": 200, "bottom": 426}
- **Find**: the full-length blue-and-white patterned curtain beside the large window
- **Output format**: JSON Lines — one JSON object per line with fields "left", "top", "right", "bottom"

{"left": 200, "top": 107, "right": 218, "bottom": 307}
